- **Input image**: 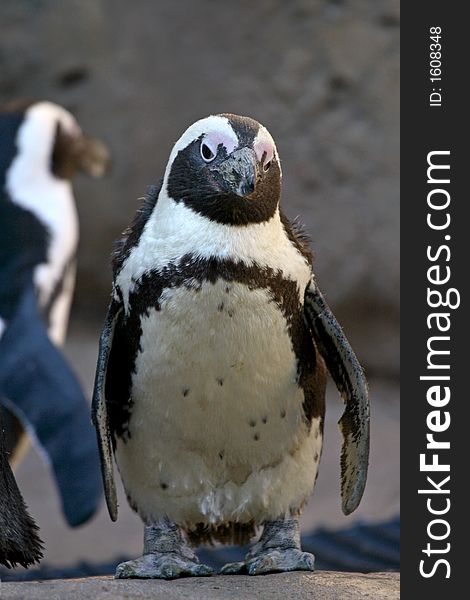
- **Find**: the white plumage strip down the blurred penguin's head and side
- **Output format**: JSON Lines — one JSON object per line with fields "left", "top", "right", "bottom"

{"left": 6, "top": 103, "right": 79, "bottom": 345}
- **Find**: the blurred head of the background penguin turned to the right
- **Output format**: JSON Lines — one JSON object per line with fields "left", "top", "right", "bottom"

{"left": 11, "top": 102, "right": 111, "bottom": 179}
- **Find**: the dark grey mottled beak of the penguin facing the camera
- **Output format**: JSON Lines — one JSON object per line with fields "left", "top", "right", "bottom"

{"left": 211, "top": 147, "right": 259, "bottom": 197}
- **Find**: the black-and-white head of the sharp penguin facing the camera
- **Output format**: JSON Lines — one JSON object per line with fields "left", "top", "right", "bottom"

{"left": 164, "top": 114, "right": 281, "bottom": 226}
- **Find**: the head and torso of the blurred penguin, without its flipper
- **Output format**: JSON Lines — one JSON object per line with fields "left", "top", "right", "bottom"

{"left": 0, "top": 102, "right": 108, "bottom": 345}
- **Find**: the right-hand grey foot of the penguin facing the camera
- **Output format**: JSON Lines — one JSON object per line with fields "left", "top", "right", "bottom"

{"left": 221, "top": 517, "right": 315, "bottom": 575}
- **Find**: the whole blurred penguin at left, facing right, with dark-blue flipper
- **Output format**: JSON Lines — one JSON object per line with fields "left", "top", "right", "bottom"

{"left": 0, "top": 102, "right": 109, "bottom": 525}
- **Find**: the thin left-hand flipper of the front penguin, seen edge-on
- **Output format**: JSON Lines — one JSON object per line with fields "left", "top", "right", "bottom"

{"left": 91, "top": 300, "right": 122, "bottom": 521}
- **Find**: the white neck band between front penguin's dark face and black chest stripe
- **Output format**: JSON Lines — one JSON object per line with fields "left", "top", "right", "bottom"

{"left": 116, "top": 187, "right": 311, "bottom": 311}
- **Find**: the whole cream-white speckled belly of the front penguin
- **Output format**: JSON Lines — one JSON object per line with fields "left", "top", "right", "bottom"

{"left": 116, "top": 280, "right": 322, "bottom": 528}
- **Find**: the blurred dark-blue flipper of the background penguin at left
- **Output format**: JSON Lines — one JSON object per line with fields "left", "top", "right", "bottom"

{"left": 0, "top": 282, "right": 102, "bottom": 526}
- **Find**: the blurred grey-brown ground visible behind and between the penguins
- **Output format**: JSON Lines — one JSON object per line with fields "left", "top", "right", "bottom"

{"left": 11, "top": 322, "right": 399, "bottom": 565}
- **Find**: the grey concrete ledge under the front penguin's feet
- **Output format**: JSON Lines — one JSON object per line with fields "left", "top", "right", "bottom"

{"left": 0, "top": 571, "right": 400, "bottom": 600}
